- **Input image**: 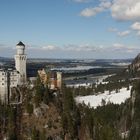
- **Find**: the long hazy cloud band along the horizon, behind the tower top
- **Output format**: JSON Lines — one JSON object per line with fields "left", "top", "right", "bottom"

{"left": 0, "top": 43, "right": 140, "bottom": 59}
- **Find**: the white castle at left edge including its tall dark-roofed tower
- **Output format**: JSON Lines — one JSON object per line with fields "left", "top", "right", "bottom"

{"left": 0, "top": 42, "right": 27, "bottom": 102}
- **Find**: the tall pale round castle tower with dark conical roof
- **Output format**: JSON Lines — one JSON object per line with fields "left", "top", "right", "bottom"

{"left": 15, "top": 42, "right": 27, "bottom": 84}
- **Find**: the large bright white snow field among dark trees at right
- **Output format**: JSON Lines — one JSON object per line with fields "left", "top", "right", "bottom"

{"left": 75, "top": 87, "right": 131, "bottom": 108}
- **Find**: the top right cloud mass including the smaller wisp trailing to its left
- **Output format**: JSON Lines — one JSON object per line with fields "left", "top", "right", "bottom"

{"left": 77, "top": 0, "right": 140, "bottom": 21}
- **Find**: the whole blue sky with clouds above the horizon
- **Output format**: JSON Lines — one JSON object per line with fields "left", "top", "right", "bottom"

{"left": 0, "top": 0, "right": 140, "bottom": 59}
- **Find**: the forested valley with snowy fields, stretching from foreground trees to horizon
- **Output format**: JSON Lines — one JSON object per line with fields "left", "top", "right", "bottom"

{"left": 0, "top": 55, "right": 139, "bottom": 140}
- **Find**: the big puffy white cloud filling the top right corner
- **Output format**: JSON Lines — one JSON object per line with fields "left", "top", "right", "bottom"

{"left": 111, "top": 0, "right": 140, "bottom": 21}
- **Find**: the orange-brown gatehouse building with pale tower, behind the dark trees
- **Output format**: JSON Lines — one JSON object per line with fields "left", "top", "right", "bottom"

{"left": 38, "top": 68, "right": 62, "bottom": 90}
